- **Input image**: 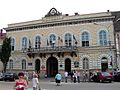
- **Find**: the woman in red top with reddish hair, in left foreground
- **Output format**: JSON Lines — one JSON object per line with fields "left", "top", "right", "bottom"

{"left": 14, "top": 72, "right": 28, "bottom": 90}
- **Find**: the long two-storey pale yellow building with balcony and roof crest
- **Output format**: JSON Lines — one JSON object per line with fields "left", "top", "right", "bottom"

{"left": 1, "top": 8, "right": 119, "bottom": 76}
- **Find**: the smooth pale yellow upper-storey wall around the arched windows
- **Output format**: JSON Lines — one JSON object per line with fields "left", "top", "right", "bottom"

{"left": 8, "top": 22, "right": 114, "bottom": 50}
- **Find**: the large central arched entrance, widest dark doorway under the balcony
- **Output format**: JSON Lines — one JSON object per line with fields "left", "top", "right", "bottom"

{"left": 46, "top": 57, "right": 58, "bottom": 77}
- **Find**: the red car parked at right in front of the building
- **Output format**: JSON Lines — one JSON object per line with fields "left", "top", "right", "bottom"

{"left": 91, "top": 72, "right": 113, "bottom": 82}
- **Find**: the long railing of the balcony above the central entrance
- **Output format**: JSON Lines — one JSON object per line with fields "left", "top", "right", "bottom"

{"left": 23, "top": 46, "right": 77, "bottom": 53}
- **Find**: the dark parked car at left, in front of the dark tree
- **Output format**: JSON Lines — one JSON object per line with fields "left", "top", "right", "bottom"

{"left": 4, "top": 73, "right": 18, "bottom": 81}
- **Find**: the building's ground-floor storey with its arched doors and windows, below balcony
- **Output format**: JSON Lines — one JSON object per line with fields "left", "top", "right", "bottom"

{"left": 3, "top": 49, "right": 114, "bottom": 77}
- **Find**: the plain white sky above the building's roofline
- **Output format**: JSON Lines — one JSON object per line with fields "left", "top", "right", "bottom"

{"left": 0, "top": 0, "right": 120, "bottom": 29}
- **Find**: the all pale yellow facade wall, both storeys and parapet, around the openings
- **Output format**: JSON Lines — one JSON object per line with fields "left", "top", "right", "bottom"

{"left": 4, "top": 12, "right": 114, "bottom": 70}
